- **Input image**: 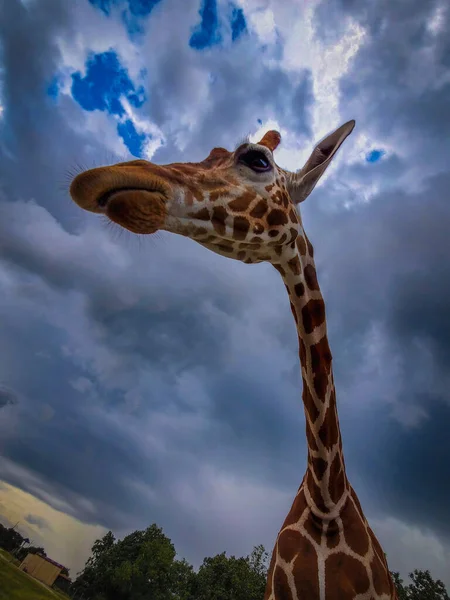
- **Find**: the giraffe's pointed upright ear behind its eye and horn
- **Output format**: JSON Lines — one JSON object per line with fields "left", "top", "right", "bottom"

{"left": 287, "top": 120, "right": 355, "bottom": 204}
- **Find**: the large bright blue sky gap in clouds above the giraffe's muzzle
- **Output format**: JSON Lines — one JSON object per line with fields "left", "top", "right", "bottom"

{"left": 72, "top": 50, "right": 145, "bottom": 117}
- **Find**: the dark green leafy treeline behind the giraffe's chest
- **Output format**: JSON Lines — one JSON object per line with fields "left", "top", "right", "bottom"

{"left": 71, "top": 524, "right": 450, "bottom": 600}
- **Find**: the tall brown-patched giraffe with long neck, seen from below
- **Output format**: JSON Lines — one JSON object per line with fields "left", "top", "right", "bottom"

{"left": 70, "top": 121, "right": 397, "bottom": 600}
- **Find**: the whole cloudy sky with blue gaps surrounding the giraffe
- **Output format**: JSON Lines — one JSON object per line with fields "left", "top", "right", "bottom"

{"left": 0, "top": 0, "right": 450, "bottom": 588}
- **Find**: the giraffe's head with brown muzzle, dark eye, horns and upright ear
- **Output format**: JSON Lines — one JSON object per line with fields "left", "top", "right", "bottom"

{"left": 70, "top": 121, "right": 355, "bottom": 264}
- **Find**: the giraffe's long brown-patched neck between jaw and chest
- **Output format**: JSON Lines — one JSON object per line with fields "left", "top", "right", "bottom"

{"left": 276, "top": 236, "right": 348, "bottom": 519}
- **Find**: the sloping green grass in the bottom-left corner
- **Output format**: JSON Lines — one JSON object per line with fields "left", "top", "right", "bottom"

{"left": 0, "top": 550, "right": 68, "bottom": 600}
